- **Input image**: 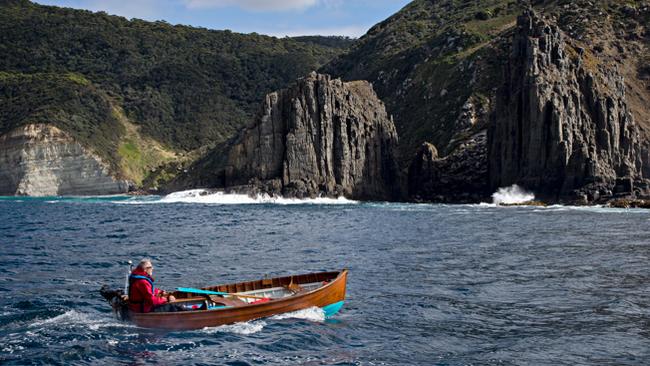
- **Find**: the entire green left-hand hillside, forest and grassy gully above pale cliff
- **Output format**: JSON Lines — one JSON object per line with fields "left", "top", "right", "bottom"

{"left": 0, "top": 0, "right": 351, "bottom": 181}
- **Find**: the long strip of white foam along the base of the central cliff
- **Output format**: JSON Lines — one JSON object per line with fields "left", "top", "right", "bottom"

{"left": 115, "top": 189, "right": 358, "bottom": 205}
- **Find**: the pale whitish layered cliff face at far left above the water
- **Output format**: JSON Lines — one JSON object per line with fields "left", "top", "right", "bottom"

{"left": 0, "top": 124, "right": 129, "bottom": 196}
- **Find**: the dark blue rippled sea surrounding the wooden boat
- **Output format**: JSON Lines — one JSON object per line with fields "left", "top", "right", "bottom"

{"left": 0, "top": 193, "right": 650, "bottom": 365}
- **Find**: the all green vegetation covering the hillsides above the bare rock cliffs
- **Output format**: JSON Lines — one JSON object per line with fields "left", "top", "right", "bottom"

{"left": 0, "top": 0, "right": 650, "bottom": 187}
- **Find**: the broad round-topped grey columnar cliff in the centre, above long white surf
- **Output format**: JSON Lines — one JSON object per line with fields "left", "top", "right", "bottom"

{"left": 223, "top": 73, "right": 399, "bottom": 200}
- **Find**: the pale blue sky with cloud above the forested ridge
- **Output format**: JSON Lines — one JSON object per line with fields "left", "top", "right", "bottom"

{"left": 31, "top": 0, "right": 410, "bottom": 37}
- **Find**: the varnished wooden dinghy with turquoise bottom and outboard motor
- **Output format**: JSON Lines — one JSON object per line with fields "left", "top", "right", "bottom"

{"left": 102, "top": 270, "right": 348, "bottom": 330}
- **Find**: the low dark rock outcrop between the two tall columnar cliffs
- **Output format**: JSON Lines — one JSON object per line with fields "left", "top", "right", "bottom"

{"left": 408, "top": 132, "right": 490, "bottom": 203}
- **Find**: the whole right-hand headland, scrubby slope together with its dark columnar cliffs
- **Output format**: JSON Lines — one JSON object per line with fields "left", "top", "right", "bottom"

{"left": 324, "top": 0, "right": 650, "bottom": 202}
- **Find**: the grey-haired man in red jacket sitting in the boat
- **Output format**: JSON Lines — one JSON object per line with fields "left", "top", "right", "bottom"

{"left": 129, "top": 258, "right": 181, "bottom": 313}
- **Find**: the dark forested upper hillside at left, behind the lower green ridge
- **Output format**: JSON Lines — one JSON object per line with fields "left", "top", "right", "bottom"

{"left": 0, "top": 1, "right": 341, "bottom": 150}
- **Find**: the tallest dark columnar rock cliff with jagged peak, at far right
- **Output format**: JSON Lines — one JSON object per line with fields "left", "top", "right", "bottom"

{"left": 488, "top": 11, "right": 646, "bottom": 201}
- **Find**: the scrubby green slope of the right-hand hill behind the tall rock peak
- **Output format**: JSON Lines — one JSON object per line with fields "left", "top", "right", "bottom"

{"left": 321, "top": 0, "right": 650, "bottom": 166}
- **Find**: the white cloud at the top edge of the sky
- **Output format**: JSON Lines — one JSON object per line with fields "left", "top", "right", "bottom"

{"left": 183, "top": 0, "right": 318, "bottom": 11}
